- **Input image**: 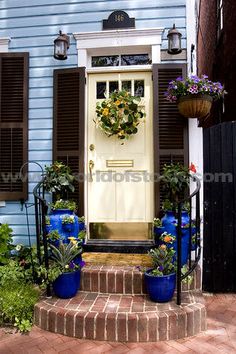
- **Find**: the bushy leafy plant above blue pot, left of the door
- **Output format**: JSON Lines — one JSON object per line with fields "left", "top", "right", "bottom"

{"left": 43, "top": 161, "right": 75, "bottom": 199}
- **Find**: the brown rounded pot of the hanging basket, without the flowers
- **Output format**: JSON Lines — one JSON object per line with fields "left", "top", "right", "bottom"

{"left": 178, "top": 95, "right": 213, "bottom": 118}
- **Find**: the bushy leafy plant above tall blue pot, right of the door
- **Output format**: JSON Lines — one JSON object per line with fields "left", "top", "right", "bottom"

{"left": 160, "top": 163, "right": 190, "bottom": 210}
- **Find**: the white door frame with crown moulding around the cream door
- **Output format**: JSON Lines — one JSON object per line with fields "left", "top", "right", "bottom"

{"left": 73, "top": 28, "right": 164, "bottom": 232}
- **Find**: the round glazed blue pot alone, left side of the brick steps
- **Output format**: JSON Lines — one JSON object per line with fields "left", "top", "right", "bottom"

{"left": 52, "top": 271, "right": 78, "bottom": 299}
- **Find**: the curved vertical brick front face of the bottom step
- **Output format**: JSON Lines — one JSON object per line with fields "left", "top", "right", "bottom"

{"left": 35, "top": 303, "right": 206, "bottom": 342}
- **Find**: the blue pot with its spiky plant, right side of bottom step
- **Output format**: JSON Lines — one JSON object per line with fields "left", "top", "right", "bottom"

{"left": 145, "top": 244, "right": 176, "bottom": 302}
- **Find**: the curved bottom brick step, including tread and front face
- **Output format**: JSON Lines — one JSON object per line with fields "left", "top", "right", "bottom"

{"left": 35, "top": 291, "right": 206, "bottom": 342}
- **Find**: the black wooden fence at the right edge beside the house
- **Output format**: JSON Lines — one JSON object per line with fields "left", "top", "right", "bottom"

{"left": 203, "top": 122, "right": 236, "bottom": 292}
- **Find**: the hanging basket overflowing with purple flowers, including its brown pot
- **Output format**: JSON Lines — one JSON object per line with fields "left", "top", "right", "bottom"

{"left": 165, "top": 75, "right": 226, "bottom": 118}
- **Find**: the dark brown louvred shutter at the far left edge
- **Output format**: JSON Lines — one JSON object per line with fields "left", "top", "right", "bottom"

{"left": 0, "top": 53, "right": 29, "bottom": 200}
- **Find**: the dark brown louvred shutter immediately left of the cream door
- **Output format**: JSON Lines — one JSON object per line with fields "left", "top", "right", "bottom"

{"left": 53, "top": 68, "right": 85, "bottom": 216}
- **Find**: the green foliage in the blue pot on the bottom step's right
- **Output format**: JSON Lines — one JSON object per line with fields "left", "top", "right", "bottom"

{"left": 148, "top": 244, "right": 176, "bottom": 276}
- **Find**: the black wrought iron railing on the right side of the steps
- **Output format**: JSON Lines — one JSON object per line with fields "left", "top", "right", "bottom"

{"left": 177, "top": 176, "right": 201, "bottom": 305}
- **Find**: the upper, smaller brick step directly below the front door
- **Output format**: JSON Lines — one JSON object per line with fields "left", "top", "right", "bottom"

{"left": 80, "top": 265, "right": 201, "bottom": 295}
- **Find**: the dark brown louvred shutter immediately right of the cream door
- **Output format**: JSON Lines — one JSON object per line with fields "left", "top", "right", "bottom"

{"left": 153, "top": 64, "right": 188, "bottom": 215}
